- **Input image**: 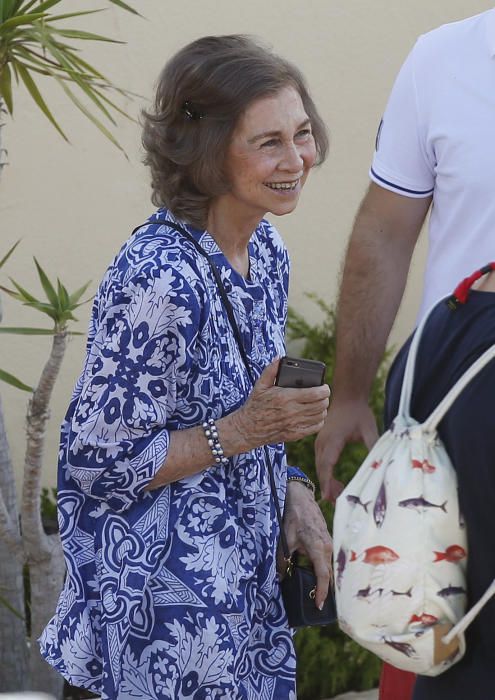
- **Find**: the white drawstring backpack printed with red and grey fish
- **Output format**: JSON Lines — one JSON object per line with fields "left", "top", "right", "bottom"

{"left": 333, "top": 263, "right": 495, "bottom": 676}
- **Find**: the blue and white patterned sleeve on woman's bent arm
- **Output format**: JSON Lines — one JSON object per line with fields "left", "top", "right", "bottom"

{"left": 66, "top": 267, "right": 201, "bottom": 512}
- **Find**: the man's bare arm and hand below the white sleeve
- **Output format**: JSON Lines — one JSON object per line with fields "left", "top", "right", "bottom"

{"left": 316, "top": 183, "right": 431, "bottom": 500}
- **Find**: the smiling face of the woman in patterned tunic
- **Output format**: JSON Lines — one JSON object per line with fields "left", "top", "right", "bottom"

{"left": 220, "top": 86, "right": 316, "bottom": 219}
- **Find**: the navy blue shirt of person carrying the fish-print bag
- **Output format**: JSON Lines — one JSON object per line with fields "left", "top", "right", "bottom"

{"left": 385, "top": 290, "right": 495, "bottom": 700}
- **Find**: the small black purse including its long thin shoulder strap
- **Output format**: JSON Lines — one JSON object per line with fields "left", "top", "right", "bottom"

{"left": 157, "top": 220, "right": 337, "bottom": 627}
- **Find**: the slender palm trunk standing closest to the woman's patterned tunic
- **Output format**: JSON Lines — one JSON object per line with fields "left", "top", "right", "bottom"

{"left": 22, "top": 327, "right": 67, "bottom": 698}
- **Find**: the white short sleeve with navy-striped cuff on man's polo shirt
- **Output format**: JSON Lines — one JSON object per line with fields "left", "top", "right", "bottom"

{"left": 370, "top": 37, "right": 435, "bottom": 197}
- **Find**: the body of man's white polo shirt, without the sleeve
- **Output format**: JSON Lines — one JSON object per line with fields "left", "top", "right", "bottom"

{"left": 417, "top": 11, "right": 495, "bottom": 316}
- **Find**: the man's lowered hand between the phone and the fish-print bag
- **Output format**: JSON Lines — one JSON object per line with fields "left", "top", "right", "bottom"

{"left": 315, "top": 399, "right": 378, "bottom": 503}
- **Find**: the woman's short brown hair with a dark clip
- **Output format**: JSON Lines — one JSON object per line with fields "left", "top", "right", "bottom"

{"left": 143, "top": 34, "right": 328, "bottom": 228}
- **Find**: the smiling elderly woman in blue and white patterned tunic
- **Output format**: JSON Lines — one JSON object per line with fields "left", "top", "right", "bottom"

{"left": 41, "top": 36, "right": 331, "bottom": 700}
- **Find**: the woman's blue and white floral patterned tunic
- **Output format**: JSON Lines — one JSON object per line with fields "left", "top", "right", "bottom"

{"left": 40, "top": 210, "right": 295, "bottom": 700}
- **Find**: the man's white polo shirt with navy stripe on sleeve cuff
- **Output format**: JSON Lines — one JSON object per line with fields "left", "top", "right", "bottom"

{"left": 370, "top": 9, "right": 495, "bottom": 315}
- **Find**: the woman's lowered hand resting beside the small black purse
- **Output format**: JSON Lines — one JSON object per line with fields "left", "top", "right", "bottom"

{"left": 278, "top": 481, "right": 333, "bottom": 608}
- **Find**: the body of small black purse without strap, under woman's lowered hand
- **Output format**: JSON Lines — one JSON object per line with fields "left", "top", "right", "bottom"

{"left": 280, "top": 554, "right": 337, "bottom": 627}
